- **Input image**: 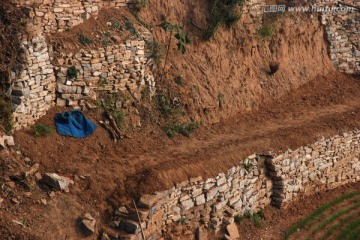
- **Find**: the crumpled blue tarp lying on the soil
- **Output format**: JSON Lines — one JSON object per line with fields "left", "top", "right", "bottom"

{"left": 55, "top": 110, "right": 96, "bottom": 138}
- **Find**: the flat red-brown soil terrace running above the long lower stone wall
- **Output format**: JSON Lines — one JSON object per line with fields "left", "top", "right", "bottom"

{"left": 1, "top": 73, "right": 360, "bottom": 239}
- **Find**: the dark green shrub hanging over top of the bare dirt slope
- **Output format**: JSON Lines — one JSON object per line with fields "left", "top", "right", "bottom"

{"left": 204, "top": 0, "right": 245, "bottom": 40}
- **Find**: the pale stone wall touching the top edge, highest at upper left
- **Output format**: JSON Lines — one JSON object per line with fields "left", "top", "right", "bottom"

{"left": 11, "top": 0, "right": 134, "bottom": 33}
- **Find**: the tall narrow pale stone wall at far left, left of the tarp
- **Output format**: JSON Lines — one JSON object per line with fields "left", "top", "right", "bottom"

{"left": 11, "top": 35, "right": 55, "bottom": 129}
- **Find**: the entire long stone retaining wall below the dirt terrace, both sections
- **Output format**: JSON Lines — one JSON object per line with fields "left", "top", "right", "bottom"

{"left": 112, "top": 131, "right": 360, "bottom": 239}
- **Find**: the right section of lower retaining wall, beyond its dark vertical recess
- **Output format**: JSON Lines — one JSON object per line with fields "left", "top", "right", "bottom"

{"left": 267, "top": 131, "right": 360, "bottom": 206}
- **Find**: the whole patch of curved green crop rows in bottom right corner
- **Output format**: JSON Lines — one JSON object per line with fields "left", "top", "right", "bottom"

{"left": 285, "top": 192, "right": 360, "bottom": 239}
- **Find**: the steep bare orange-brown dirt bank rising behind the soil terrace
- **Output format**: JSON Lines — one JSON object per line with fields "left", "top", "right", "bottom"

{"left": 136, "top": 0, "right": 334, "bottom": 123}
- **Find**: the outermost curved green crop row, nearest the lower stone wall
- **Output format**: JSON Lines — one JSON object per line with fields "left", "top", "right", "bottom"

{"left": 285, "top": 192, "right": 360, "bottom": 239}
